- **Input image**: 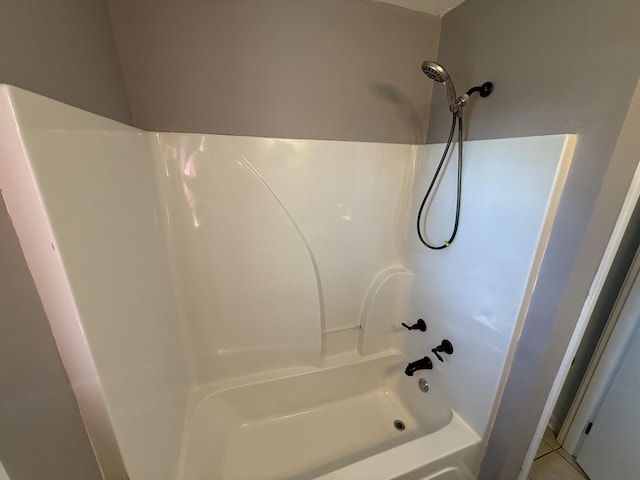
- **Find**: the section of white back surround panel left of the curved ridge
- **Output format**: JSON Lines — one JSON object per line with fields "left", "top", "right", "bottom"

{"left": 158, "top": 134, "right": 321, "bottom": 383}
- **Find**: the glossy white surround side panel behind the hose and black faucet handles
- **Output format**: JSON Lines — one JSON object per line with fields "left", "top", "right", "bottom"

{"left": 404, "top": 135, "right": 575, "bottom": 436}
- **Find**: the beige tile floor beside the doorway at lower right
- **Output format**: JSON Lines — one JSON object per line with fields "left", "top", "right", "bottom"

{"left": 529, "top": 428, "right": 589, "bottom": 480}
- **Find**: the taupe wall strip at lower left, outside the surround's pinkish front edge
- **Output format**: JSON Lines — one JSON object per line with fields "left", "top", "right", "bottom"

{"left": 0, "top": 198, "right": 102, "bottom": 480}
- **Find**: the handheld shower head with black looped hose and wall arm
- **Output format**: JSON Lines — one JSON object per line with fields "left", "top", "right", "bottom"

{"left": 416, "top": 60, "right": 493, "bottom": 250}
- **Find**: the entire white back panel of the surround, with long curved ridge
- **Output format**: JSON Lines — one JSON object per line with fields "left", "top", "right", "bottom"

{"left": 158, "top": 133, "right": 415, "bottom": 380}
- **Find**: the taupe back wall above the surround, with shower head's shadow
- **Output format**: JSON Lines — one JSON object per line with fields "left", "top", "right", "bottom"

{"left": 109, "top": 0, "right": 440, "bottom": 143}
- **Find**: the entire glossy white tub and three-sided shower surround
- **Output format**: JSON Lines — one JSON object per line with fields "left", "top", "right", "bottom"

{"left": 0, "top": 86, "right": 575, "bottom": 480}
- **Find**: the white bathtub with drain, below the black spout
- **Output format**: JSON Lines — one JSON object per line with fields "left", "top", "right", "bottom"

{"left": 179, "top": 353, "right": 479, "bottom": 480}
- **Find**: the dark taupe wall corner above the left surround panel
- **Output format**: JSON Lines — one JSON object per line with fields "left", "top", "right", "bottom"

{"left": 0, "top": 0, "right": 131, "bottom": 123}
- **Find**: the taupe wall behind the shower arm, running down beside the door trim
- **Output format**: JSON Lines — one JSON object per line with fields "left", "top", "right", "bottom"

{"left": 428, "top": 0, "right": 640, "bottom": 480}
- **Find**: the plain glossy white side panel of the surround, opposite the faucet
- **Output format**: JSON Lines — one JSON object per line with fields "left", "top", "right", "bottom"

{"left": 0, "top": 89, "right": 189, "bottom": 480}
